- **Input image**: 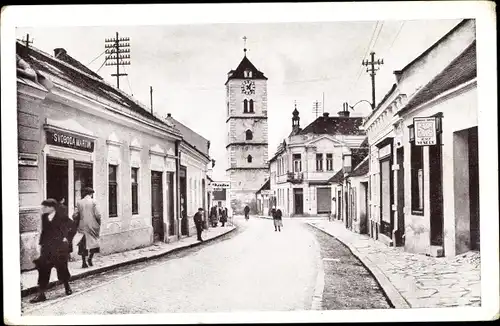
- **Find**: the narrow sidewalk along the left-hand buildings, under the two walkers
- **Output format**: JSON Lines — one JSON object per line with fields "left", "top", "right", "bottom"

{"left": 21, "top": 226, "right": 236, "bottom": 297}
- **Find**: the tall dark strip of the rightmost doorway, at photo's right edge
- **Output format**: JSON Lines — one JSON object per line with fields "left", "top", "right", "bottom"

{"left": 468, "top": 127, "right": 480, "bottom": 250}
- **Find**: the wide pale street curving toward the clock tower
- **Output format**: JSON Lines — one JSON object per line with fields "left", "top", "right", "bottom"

{"left": 23, "top": 218, "right": 389, "bottom": 315}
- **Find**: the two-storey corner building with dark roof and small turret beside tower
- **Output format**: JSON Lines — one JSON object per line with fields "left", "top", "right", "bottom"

{"left": 269, "top": 103, "right": 366, "bottom": 216}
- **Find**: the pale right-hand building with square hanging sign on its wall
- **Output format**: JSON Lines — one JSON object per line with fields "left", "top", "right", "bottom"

{"left": 364, "top": 19, "right": 480, "bottom": 256}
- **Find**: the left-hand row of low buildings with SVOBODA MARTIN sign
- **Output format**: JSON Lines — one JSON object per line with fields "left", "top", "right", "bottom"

{"left": 16, "top": 42, "right": 210, "bottom": 270}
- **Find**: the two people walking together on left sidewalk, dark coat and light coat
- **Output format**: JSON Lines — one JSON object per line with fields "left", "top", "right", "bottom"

{"left": 30, "top": 187, "right": 101, "bottom": 303}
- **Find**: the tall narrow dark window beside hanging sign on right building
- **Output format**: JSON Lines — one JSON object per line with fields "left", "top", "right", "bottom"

{"left": 410, "top": 126, "right": 424, "bottom": 213}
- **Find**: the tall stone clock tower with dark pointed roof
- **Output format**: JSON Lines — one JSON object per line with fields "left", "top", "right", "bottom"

{"left": 226, "top": 38, "right": 269, "bottom": 214}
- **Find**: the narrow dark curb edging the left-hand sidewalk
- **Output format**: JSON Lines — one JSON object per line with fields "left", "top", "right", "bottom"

{"left": 21, "top": 226, "right": 237, "bottom": 297}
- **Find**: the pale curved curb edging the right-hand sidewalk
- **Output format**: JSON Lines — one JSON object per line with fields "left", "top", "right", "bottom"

{"left": 307, "top": 222, "right": 411, "bottom": 309}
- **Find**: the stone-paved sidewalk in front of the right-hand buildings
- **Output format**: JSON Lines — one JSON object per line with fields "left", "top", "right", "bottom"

{"left": 307, "top": 220, "right": 481, "bottom": 308}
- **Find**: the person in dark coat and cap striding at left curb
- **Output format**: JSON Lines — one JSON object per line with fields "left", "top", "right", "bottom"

{"left": 30, "top": 199, "right": 73, "bottom": 303}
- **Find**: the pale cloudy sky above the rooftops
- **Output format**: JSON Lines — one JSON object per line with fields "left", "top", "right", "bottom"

{"left": 16, "top": 19, "right": 460, "bottom": 181}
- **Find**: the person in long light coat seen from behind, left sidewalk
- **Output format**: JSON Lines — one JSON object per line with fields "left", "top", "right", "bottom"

{"left": 73, "top": 187, "right": 101, "bottom": 268}
